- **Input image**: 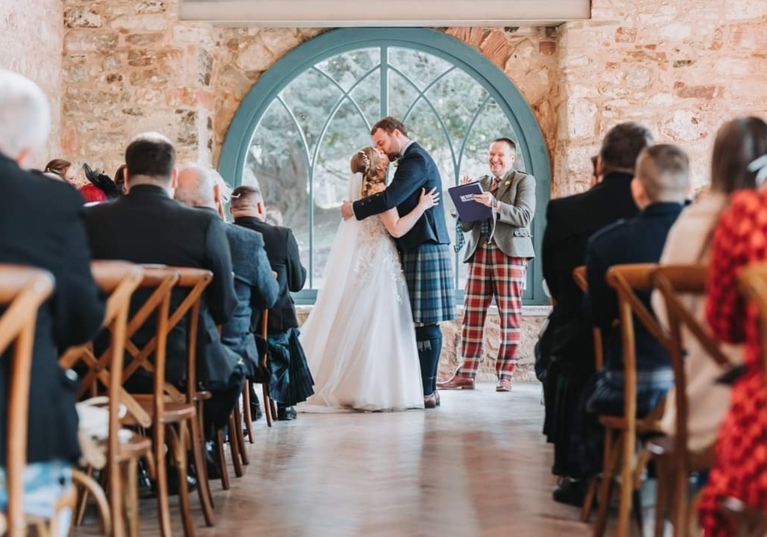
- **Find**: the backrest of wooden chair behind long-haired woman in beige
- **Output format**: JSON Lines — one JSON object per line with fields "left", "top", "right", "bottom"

{"left": 652, "top": 265, "right": 734, "bottom": 455}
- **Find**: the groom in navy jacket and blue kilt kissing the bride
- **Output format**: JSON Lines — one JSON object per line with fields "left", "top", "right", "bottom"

{"left": 341, "top": 117, "right": 455, "bottom": 408}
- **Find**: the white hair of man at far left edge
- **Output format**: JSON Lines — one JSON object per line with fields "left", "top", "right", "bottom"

{"left": 0, "top": 69, "right": 51, "bottom": 159}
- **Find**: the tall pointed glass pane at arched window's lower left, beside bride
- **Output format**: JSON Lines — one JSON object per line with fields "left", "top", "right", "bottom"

{"left": 242, "top": 100, "right": 309, "bottom": 285}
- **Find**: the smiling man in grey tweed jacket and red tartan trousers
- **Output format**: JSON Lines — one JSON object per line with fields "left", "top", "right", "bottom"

{"left": 439, "top": 138, "right": 535, "bottom": 392}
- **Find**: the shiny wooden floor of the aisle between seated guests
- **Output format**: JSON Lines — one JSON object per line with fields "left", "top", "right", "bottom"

{"left": 76, "top": 383, "right": 638, "bottom": 537}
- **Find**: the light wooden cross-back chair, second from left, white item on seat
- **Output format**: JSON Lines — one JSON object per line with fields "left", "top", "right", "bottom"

{"left": 59, "top": 261, "right": 149, "bottom": 537}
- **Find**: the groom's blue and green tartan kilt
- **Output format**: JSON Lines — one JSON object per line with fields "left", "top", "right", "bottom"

{"left": 401, "top": 243, "right": 455, "bottom": 324}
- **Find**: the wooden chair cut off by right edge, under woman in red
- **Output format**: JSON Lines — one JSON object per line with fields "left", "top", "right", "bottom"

{"left": 720, "top": 263, "right": 767, "bottom": 537}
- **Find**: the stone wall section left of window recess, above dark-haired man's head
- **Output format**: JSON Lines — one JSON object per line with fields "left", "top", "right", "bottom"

{"left": 61, "top": 0, "right": 219, "bottom": 174}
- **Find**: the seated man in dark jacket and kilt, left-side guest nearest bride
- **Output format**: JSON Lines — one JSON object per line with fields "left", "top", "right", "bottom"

{"left": 229, "top": 186, "right": 314, "bottom": 419}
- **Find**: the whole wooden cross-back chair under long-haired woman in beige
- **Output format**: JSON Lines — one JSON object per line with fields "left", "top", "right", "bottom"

{"left": 647, "top": 265, "right": 735, "bottom": 537}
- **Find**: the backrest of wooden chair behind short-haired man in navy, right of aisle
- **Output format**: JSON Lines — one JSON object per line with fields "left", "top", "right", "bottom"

{"left": 607, "top": 263, "right": 670, "bottom": 427}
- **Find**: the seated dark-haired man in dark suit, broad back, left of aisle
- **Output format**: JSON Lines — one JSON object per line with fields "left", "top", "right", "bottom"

{"left": 86, "top": 133, "right": 244, "bottom": 439}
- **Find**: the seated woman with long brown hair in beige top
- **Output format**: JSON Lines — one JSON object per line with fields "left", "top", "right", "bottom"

{"left": 653, "top": 117, "right": 767, "bottom": 451}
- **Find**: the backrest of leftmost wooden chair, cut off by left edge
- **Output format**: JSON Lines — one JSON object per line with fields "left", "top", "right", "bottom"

{"left": 0, "top": 265, "right": 54, "bottom": 537}
